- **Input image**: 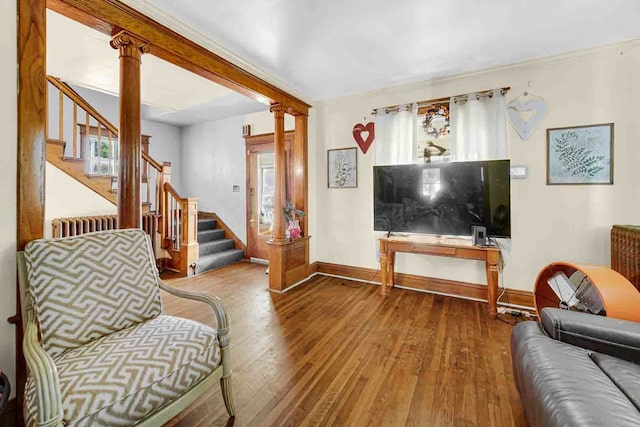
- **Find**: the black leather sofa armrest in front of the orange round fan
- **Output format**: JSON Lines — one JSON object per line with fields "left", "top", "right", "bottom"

{"left": 540, "top": 308, "right": 640, "bottom": 363}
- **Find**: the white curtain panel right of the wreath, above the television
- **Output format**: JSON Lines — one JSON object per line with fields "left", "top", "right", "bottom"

{"left": 449, "top": 89, "right": 508, "bottom": 161}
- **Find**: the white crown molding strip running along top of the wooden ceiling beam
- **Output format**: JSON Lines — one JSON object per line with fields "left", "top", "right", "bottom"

{"left": 120, "top": 0, "right": 312, "bottom": 105}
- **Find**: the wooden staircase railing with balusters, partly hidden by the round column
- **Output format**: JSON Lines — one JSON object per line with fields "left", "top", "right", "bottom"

{"left": 46, "top": 76, "right": 198, "bottom": 274}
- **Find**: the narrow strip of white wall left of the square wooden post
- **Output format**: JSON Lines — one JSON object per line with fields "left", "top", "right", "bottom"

{"left": 0, "top": 1, "right": 18, "bottom": 396}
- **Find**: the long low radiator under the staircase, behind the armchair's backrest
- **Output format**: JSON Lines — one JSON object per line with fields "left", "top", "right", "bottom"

{"left": 51, "top": 216, "right": 158, "bottom": 253}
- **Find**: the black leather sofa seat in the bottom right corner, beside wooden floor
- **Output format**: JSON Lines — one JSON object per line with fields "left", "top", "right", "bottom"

{"left": 511, "top": 322, "right": 640, "bottom": 427}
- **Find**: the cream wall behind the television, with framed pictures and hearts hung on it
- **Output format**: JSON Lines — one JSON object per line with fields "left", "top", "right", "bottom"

{"left": 310, "top": 42, "right": 640, "bottom": 290}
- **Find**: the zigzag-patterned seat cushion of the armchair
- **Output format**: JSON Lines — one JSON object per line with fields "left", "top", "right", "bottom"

{"left": 25, "top": 315, "right": 221, "bottom": 426}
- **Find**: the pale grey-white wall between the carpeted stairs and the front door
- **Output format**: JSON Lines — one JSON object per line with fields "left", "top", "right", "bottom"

{"left": 181, "top": 116, "right": 247, "bottom": 243}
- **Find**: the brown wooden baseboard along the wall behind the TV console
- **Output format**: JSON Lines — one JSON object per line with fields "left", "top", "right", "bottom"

{"left": 312, "top": 262, "right": 533, "bottom": 310}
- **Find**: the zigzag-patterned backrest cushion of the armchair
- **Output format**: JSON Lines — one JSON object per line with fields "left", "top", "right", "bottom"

{"left": 25, "top": 229, "right": 162, "bottom": 357}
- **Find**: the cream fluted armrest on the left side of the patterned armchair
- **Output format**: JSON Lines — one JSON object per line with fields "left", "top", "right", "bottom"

{"left": 22, "top": 310, "right": 63, "bottom": 427}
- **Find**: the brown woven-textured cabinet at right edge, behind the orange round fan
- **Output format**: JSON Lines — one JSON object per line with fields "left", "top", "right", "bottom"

{"left": 611, "top": 225, "right": 640, "bottom": 291}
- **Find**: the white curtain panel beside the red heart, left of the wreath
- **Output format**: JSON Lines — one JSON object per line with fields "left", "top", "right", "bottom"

{"left": 375, "top": 104, "right": 418, "bottom": 165}
